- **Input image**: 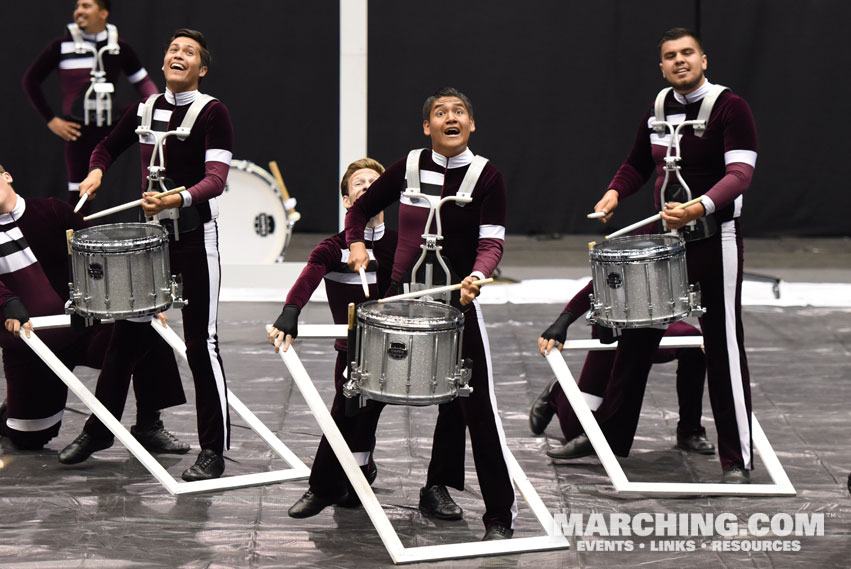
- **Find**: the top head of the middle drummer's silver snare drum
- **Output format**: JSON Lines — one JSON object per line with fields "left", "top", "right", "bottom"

{"left": 358, "top": 300, "right": 463, "bottom": 330}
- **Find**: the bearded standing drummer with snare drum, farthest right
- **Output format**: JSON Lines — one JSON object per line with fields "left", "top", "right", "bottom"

{"left": 594, "top": 28, "right": 757, "bottom": 484}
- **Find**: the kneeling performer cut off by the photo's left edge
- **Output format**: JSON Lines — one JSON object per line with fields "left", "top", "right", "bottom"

{"left": 0, "top": 162, "right": 189, "bottom": 453}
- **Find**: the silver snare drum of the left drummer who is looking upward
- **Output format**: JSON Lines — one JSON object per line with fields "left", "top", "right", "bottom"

{"left": 69, "top": 223, "right": 175, "bottom": 319}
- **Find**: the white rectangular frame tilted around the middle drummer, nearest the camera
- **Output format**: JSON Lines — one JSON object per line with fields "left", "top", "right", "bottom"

{"left": 280, "top": 325, "right": 570, "bottom": 564}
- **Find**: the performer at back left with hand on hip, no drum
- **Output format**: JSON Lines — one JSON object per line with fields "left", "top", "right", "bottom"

{"left": 23, "top": 0, "right": 158, "bottom": 209}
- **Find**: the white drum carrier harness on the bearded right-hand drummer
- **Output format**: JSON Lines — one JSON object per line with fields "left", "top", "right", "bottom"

{"left": 651, "top": 85, "right": 727, "bottom": 241}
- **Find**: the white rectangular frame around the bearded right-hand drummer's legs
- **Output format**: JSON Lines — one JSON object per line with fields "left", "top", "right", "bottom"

{"left": 546, "top": 336, "right": 796, "bottom": 496}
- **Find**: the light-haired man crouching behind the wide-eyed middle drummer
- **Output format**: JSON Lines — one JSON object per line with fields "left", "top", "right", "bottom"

{"left": 269, "top": 158, "right": 398, "bottom": 518}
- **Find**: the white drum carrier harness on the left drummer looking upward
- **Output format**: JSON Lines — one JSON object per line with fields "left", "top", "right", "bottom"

{"left": 136, "top": 93, "right": 218, "bottom": 237}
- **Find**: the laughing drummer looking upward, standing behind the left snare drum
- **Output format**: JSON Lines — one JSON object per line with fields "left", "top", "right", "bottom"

{"left": 60, "top": 28, "right": 233, "bottom": 481}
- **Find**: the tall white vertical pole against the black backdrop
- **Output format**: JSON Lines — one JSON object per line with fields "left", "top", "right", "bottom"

{"left": 337, "top": 0, "right": 368, "bottom": 230}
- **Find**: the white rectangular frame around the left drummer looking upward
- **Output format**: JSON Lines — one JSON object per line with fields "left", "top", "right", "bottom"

{"left": 21, "top": 315, "right": 310, "bottom": 495}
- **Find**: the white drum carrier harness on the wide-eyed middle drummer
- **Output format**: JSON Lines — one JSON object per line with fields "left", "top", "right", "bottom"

{"left": 402, "top": 148, "right": 488, "bottom": 303}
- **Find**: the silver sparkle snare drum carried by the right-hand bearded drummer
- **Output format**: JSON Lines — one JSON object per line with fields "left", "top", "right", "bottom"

{"left": 588, "top": 235, "right": 703, "bottom": 328}
